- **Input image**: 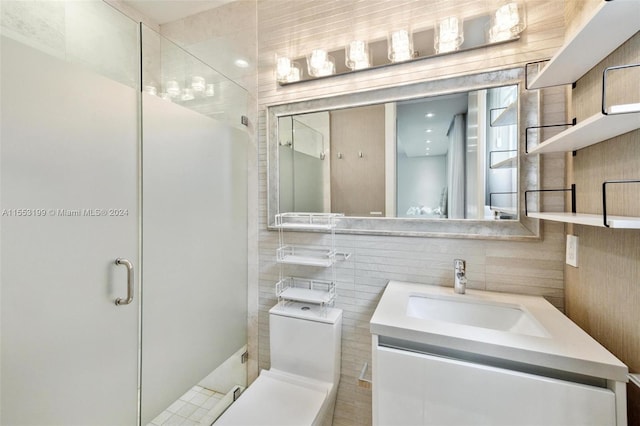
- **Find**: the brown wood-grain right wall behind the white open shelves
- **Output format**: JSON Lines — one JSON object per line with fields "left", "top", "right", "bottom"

{"left": 565, "top": 1, "right": 640, "bottom": 425}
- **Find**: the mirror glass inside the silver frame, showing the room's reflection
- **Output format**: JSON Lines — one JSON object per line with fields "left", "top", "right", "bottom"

{"left": 278, "top": 84, "right": 518, "bottom": 220}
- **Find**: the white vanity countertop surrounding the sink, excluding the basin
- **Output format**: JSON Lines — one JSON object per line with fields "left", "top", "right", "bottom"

{"left": 370, "top": 281, "right": 628, "bottom": 382}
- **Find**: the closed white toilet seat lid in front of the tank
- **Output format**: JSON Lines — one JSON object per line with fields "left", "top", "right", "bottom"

{"left": 214, "top": 370, "right": 332, "bottom": 426}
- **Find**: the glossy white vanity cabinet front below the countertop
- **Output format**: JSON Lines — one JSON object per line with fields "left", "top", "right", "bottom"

{"left": 373, "top": 339, "right": 616, "bottom": 426}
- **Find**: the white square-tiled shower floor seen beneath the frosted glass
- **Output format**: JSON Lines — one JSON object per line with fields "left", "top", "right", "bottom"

{"left": 148, "top": 386, "right": 224, "bottom": 426}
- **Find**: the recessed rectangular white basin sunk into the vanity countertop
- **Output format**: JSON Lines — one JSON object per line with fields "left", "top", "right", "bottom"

{"left": 406, "top": 296, "right": 548, "bottom": 337}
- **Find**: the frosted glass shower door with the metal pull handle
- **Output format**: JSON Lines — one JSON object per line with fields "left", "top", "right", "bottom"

{"left": 0, "top": 1, "right": 139, "bottom": 426}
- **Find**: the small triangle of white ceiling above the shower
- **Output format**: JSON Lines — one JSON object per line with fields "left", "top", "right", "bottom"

{"left": 122, "top": 0, "right": 233, "bottom": 25}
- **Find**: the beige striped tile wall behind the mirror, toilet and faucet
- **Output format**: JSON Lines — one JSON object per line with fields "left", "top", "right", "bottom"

{"left": 255, "top": 0, "right": 565, "bottom": 426}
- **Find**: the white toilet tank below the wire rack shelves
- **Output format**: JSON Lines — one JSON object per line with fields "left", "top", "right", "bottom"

{"left": 269, "top": 302, "right": 342, "bottom": 385}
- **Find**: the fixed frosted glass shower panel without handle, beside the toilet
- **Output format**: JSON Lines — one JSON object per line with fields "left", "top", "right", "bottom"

{"left": 141, "top": 26, "right": 248, "bottom": 424}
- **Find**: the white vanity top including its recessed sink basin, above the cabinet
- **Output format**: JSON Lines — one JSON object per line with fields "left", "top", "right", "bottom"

{"left": 370, "top": 281, "right": 628, "bottom": 382}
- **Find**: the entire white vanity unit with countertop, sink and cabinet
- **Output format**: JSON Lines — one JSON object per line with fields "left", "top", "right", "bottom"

{"left": 370, "top": 281, "right": 629, "bottom": 426}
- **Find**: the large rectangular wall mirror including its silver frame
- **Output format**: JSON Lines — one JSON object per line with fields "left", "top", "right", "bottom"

{"left": 268, "top": 68, "right": 538, "bottom": 238}
